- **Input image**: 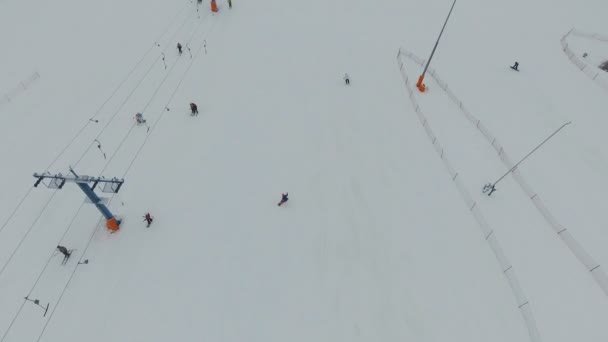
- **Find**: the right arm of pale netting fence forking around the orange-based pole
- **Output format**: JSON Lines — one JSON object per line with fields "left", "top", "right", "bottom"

{"left": 399, "top": 49, "right": 608, "bottom": 296}
